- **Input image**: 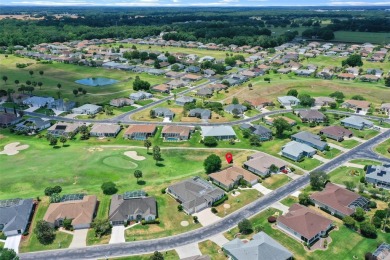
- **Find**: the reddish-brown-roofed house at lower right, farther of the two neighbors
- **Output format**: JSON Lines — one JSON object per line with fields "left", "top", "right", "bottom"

{"left": 310, "top": 182, "right": 369, "bottom": 217}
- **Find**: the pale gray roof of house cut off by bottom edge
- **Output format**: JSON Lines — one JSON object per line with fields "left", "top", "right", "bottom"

{"left": 222, "top": 232, "right": 293, "bottom": 260}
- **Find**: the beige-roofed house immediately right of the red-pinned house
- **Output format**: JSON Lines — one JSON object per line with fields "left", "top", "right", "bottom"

{"left": 243, "top": 152, "right": 287, "bottom": 177}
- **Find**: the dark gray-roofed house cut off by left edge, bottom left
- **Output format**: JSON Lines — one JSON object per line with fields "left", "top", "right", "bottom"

{"left": 0, "top": 199, "right": 34, "bottom": 236}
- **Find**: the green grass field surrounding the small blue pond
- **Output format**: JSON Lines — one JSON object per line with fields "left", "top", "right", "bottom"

{"left": 0, "top": 55, "right": 167, "bottom": 104}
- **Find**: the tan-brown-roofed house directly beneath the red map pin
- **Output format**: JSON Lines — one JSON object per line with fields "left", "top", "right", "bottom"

{"left": 209, "top": 166, "right": 258, "bottom": 191}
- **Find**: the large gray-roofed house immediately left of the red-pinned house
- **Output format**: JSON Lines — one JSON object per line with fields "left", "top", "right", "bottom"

{"left": 167, "top": 177, "right": 225, "bottom": 214}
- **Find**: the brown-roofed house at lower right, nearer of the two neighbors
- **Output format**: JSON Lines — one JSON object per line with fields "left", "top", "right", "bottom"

{"left": 277, "top": 204, "right": 333, "bottom": 245}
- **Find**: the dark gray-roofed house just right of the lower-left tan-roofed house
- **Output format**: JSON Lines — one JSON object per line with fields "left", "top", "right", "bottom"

{"left": 108, "top": 191, "right": 157, "bottom": 226}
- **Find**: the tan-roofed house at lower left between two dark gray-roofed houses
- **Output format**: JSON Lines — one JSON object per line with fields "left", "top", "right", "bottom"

{"left": 43, "top": 194, "right": 98, "bottom": 229}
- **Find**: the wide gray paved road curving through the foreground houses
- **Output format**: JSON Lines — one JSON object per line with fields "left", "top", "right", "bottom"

{"left": 20, "top": 130, "right": 390, "bottom": 259}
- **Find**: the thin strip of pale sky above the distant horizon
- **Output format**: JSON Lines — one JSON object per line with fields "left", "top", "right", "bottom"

{"left": 0, "top": 0, "right": 390, "bottom": 7}
